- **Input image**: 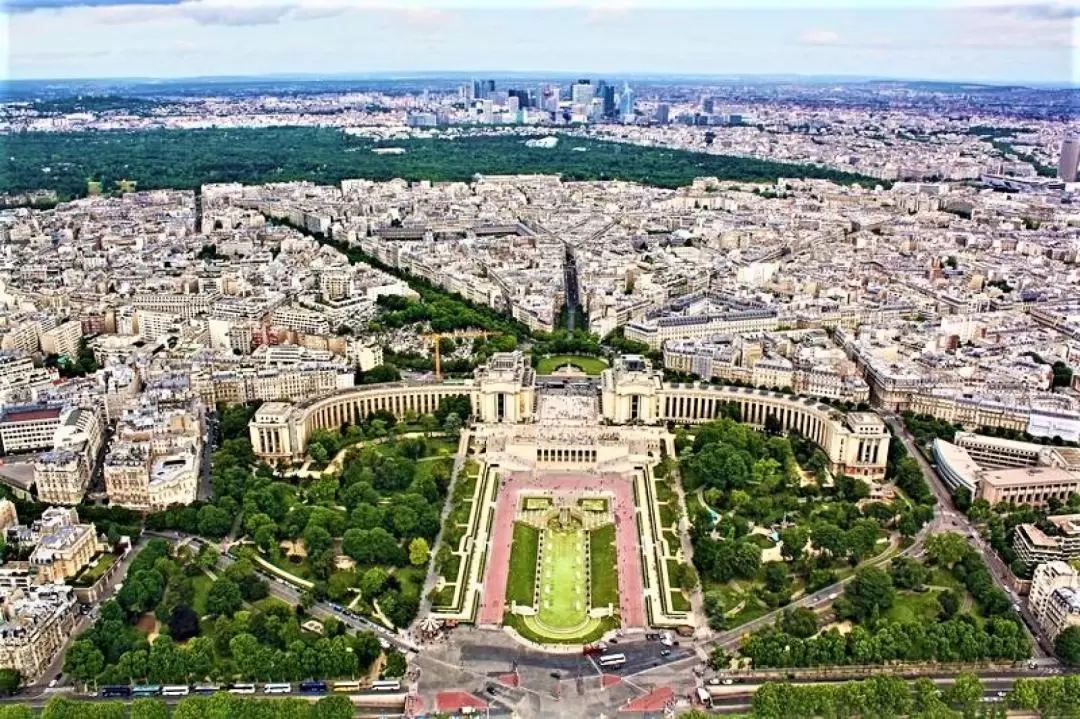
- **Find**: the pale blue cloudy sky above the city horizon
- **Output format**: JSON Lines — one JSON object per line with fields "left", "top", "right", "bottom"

{"left": 0, "top": 0, "right": 1080, "bottom": 84}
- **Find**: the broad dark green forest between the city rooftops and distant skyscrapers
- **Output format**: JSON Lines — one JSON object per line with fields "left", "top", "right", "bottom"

{"left": 0, "top": 127, "right": 876, "bottom": 198}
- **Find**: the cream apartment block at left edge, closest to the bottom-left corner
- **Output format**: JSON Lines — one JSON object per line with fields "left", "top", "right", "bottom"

{"left": 0, "top": 584, "right": 78, "bottom": 683}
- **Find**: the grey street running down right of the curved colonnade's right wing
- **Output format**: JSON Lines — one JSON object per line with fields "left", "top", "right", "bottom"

{"left": 882, "top": 413, "right": 1056, "bottom": 664}
